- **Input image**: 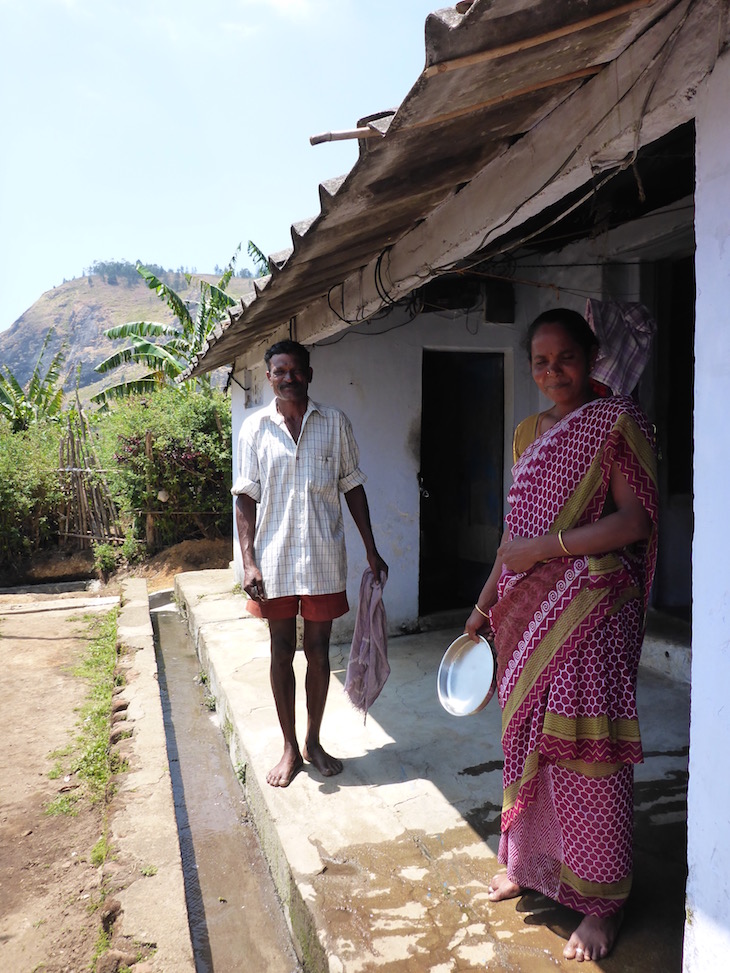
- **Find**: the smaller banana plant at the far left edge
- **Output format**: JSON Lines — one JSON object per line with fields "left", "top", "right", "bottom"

{"left": 0, "top": 328, "right": 66, "bottom": 432}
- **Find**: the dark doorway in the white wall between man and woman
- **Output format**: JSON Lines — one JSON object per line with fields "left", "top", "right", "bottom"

{"left": 419, "top": 351, "right": 504, "bottom": 615}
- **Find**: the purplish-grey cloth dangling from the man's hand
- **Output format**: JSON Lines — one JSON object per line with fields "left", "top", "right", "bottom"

{"left": 345, "top": 568, "right": 390, "bottom": 719}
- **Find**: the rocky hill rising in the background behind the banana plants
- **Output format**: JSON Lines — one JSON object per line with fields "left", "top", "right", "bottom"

{"left": 0, "top": 272, "right": 253, "bottom": 400}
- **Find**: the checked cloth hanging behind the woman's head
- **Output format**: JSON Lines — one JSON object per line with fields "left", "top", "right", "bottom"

{"left": 585, "top": 299, "right": 656, "bottom": 395}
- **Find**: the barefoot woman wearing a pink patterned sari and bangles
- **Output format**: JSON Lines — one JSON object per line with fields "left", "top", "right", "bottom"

{"left": 466, "top": 308, "right": 657, "bottom": 962}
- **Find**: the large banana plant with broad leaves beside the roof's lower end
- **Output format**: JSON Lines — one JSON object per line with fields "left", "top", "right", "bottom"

{"left": 91, "top": 244, "right": 241, "bottom": 407}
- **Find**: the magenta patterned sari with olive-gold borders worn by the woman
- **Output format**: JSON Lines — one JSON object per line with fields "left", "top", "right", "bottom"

{"left": 491, "top": 396, "right": 657, "bottom": 915}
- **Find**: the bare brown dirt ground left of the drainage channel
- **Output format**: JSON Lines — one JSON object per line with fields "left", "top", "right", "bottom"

{"left": 0, "top": 539, "right": 231, "bottom": 973}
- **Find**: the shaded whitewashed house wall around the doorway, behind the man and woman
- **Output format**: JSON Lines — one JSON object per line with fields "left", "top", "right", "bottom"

{"left": 232, "top": 225, "right": 666, "bottom": 640}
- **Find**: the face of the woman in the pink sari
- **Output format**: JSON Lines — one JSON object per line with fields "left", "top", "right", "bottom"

{"left": 531, "top": 323, "right": 595, "bottom": 414}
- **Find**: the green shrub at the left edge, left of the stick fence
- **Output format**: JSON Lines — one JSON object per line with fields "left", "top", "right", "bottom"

{"left": 0, "top": 420, "right": 63, "bottom": 566}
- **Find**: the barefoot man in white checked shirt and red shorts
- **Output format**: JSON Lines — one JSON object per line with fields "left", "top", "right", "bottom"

{"left": 232, "top": 341, "right": 388, "bottom": 787}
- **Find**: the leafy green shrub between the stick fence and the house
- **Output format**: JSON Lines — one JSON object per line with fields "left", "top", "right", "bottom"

{"left": 94, "top": 388, "right": 231, "bottom": 547}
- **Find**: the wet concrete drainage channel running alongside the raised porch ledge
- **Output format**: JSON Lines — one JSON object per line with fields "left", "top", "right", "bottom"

{"left": 151, "top": 605, "right": 301, "bottom": 973}
